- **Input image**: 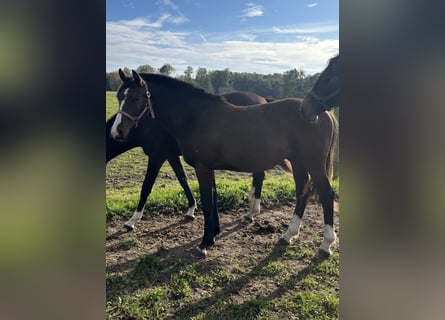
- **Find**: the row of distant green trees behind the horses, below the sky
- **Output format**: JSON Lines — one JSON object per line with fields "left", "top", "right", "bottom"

{"left": 105, "top": 64, "right": 321, "bottom": 99}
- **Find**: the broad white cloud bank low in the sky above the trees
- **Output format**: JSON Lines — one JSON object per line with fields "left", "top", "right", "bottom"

{"left": 106, "top": 19, "right": 339, "bottom": 74}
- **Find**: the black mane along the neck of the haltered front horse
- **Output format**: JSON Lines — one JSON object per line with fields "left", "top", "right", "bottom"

{"left": 139, "top": 73, "right": 226, "bottom": 102}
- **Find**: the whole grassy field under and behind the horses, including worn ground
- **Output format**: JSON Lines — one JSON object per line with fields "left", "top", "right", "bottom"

{"left": 106, "top": 92, "right": 339, "bottom": 320}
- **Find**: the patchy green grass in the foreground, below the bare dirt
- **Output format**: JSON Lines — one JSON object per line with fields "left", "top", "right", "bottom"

{"left": 106, "top": 252, "right": 339, "bottom": 320}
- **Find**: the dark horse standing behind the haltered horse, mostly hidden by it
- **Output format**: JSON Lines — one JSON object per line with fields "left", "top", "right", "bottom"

{"left": 106, "top": 92, "right": 292, "bottom": 230}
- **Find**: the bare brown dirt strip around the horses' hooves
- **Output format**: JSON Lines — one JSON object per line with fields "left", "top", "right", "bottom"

{"left": 106, "top": 203, "right": 339, "bottom": 284}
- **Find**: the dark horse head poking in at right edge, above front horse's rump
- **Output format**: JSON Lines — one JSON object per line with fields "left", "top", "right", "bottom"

{"left": 301, "top": 55, "right": 340, "bottom": 121}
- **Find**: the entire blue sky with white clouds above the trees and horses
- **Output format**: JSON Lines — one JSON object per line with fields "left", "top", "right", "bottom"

{"left": 106, "top": 0, "right": 339, "bottom": 75}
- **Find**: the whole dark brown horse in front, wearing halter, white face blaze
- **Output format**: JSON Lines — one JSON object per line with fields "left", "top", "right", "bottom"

{"left": 111, "top": 71, "right": 338, "bottom": 255}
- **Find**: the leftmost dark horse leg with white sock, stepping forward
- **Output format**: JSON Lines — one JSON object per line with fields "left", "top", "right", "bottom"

{"left": 124, "top": 155, "right": 166, "bottom": 231}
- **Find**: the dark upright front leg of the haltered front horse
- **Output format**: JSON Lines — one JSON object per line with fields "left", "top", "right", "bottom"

{"left": 195, "top": 164, "right": 219, "bottom": 256}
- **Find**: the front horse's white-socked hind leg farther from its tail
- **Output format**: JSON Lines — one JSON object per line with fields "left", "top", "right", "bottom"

{"left": 279, "top": 165, "right": 311, "bottom": 245}
